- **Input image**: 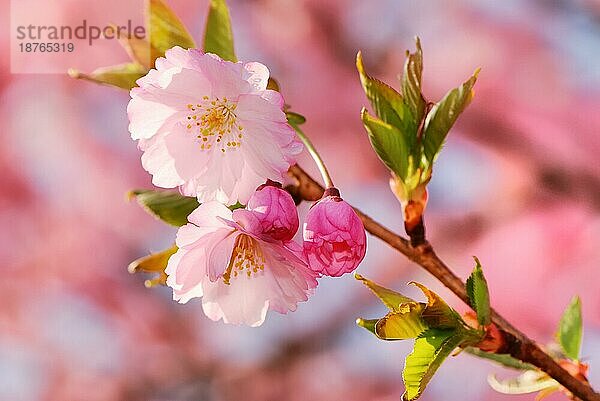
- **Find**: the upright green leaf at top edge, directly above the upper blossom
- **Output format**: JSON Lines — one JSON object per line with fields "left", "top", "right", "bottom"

{"left": 204, "top": 0, "right": 237, "bottom": 62}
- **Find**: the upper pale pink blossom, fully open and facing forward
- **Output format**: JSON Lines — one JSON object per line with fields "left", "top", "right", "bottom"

{"left": 127, "top": 47, "right": 302, "bottom": 204}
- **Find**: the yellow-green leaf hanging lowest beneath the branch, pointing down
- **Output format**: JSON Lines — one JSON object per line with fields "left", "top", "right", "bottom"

{"left": 402, "top": 329, "right": 463, "bottom": 401}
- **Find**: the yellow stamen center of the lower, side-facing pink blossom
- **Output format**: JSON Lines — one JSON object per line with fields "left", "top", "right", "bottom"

{"left": 223, "top": 234, "right": 265, "bottom": 285}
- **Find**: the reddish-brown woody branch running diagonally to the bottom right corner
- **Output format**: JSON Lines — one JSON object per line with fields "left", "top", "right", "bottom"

{"left": 288, "top": 165, "right": 600, "bottom": 401}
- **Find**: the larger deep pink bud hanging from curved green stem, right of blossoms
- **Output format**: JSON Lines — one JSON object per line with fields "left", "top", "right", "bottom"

{"left": 304, "top": 190, "right": 367, "bottom": 277}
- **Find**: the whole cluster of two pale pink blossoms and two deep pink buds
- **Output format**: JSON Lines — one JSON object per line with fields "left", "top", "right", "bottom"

{"left": 128, "top": 47, "right": 366, "bottom": 326}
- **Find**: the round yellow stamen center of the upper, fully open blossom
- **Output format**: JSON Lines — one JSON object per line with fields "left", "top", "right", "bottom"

{"left": 187, "top": 96, "right": 244, "bottom": 153}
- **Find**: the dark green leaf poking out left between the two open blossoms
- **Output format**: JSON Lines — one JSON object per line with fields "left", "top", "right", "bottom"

{"left": 129, "top": 189, "right": 200, "bottom": 227}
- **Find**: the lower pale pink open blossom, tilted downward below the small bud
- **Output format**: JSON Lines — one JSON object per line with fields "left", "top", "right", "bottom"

{"left": 166, "top": 195, "right": 317, "bottom": 326}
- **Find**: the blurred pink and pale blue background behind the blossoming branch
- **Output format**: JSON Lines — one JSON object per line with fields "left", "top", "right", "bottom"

{"left": 0, "top": 0, "right": 600, "bottom": 401}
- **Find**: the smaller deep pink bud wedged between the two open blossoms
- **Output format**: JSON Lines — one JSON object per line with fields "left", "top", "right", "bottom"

{"left": 246, "top": 185, "right": 300, "bottom": 241}
